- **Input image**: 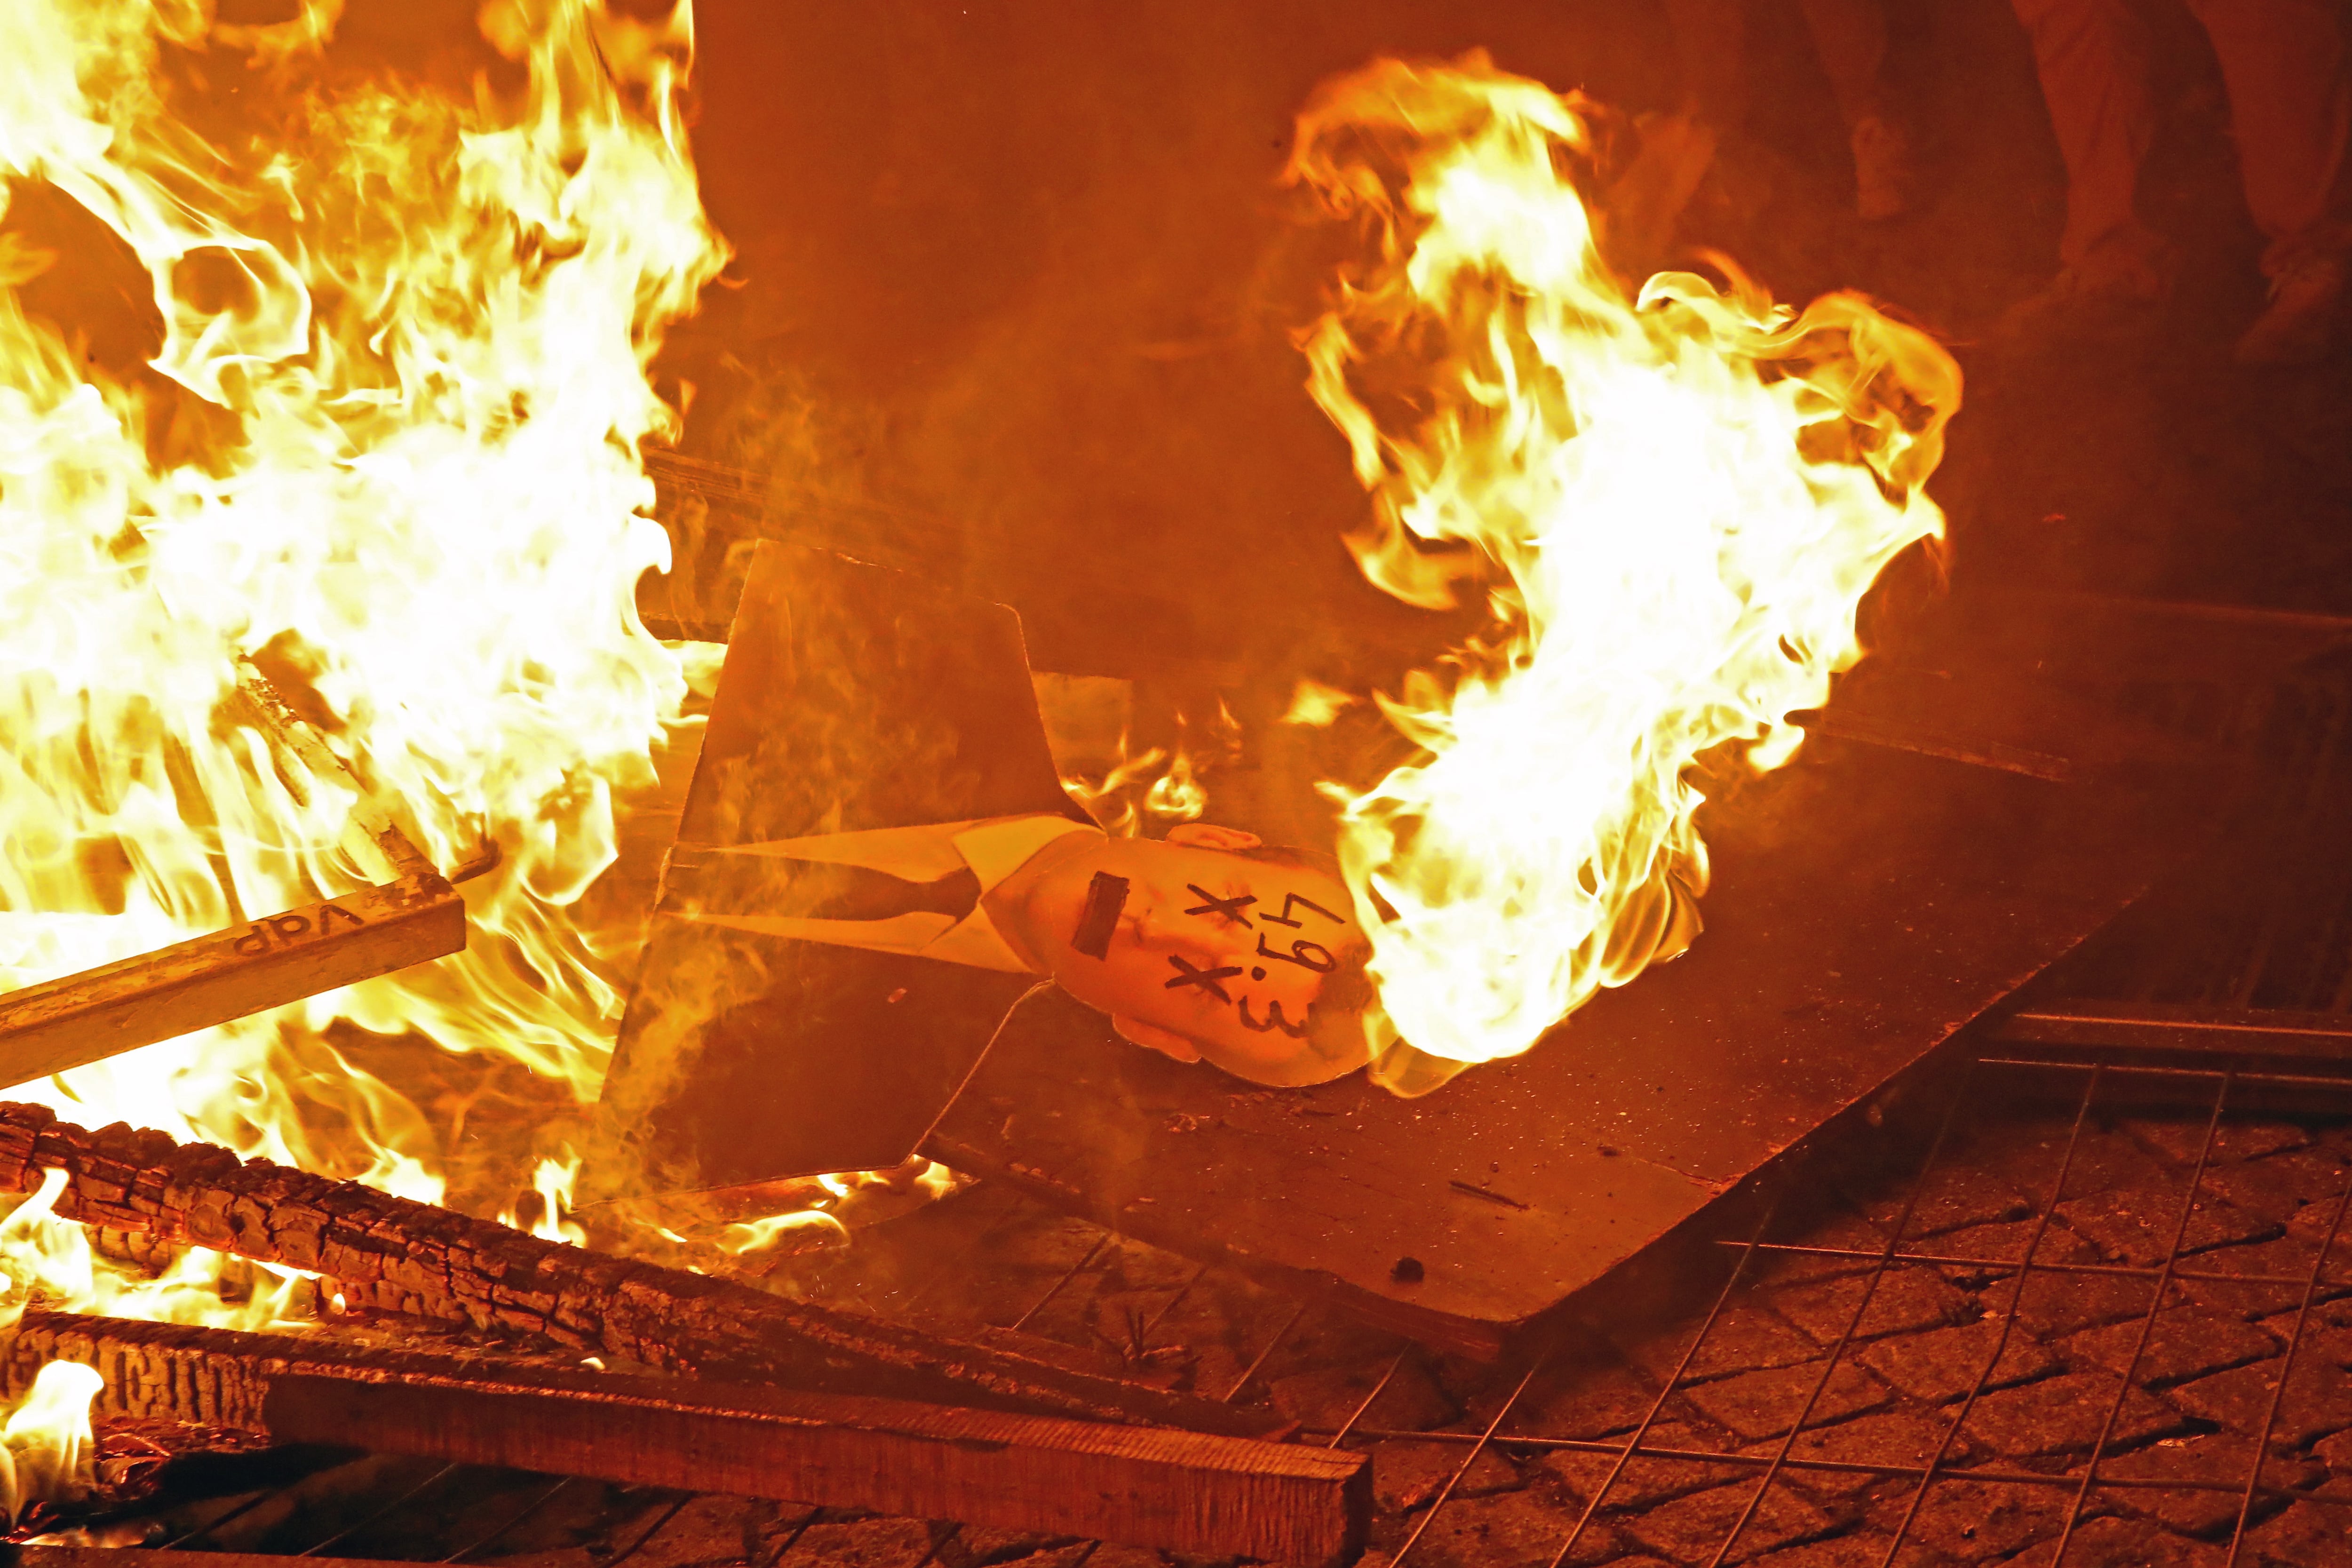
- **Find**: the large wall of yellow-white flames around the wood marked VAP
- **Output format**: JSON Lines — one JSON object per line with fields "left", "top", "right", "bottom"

{"left": 0, "top": 0, "right": 727, "bottom": 1295}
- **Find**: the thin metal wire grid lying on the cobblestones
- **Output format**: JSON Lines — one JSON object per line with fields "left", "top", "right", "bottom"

{"left": 1329, "top": 1060, "right": 2352, "bottom": 1568}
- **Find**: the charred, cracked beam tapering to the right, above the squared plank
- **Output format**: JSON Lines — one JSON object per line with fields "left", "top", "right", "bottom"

{"left": 0, "top": 1103, "right": 1279, "bottom": 1436}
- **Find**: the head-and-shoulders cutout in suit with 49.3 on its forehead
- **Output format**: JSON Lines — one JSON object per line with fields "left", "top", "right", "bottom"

{"left": 602, "top": 543, "right": 1369, "bottom": 1192}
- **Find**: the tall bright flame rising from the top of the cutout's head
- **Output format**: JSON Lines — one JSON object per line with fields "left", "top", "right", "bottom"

{"left": 1289, "top": 54, "right": 1959, "bottom": 1086}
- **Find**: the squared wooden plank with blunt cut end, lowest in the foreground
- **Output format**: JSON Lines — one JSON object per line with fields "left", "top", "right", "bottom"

{"left": 5, "top": 1314, "right": 1371, "bottom": 1566}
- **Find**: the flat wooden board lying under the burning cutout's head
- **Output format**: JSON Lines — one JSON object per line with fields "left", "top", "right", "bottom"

{"left": 927, "top": 738, "right": 2183, "bottom": 1354}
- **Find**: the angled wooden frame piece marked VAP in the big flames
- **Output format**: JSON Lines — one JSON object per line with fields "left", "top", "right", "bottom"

{"left": 0, "top": 668, "right": 466, "bottom": 1100}
